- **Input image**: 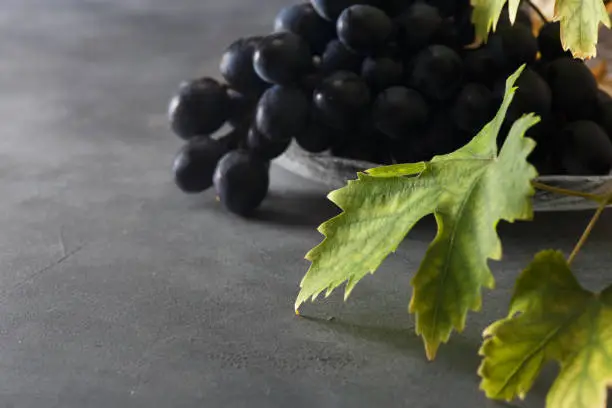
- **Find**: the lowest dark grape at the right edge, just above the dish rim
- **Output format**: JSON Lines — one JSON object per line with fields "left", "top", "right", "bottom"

{"left": 559, "top": 120, "right": 612, "bottom": 176}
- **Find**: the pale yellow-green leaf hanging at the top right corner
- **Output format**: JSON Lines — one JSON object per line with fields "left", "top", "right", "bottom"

{"left": 554, "top": 0, "right": 610, "bottom": 58}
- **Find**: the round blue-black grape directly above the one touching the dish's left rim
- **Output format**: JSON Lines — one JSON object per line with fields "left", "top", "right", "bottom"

{"left": 255, "top": 85, "right": 310, "bottom": 141}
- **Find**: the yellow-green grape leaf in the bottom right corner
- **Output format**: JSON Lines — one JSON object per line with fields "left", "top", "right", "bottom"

{"left": 479, "top": 250, "right": 612, "bottom": 408}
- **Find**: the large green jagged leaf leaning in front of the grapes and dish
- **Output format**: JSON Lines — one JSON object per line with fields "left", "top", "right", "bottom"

{"left": 295, "top": 66, "right": 539, "bottom": 359}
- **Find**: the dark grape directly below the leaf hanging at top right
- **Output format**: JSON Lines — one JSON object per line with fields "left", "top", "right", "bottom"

{"left": 546, "top": 58, "right": 598, "bottom": 119}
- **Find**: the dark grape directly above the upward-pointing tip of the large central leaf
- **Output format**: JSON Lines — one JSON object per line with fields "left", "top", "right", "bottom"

{"left": 488, "top": 24, "right": 538, "bottom": 72}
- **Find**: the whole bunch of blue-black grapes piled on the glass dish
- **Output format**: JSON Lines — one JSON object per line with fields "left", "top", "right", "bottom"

{"left": 169, "top": 0, "right": 612, "bottom": 215}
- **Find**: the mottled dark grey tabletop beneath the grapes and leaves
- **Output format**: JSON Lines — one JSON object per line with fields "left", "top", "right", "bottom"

{"left": 0, "top": 0, "right": 612, "bottom": 408}
